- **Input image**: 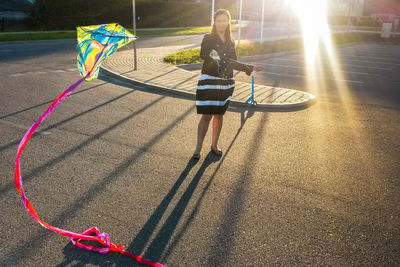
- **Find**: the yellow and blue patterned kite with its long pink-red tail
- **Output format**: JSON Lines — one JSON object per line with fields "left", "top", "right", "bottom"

{"left": 14, "top": 23, "right": 164, "bottom": 267}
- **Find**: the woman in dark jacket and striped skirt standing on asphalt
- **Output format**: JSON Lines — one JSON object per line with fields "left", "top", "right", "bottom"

{"left": 193, "top": 9, "right": 263, "bottom": 159}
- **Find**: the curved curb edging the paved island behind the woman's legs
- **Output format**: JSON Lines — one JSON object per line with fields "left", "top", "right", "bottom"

{"left": 100, "top": 67, "right": 316, "bottom": 110}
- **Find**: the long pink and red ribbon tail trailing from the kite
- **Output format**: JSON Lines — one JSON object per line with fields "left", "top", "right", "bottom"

{"left": 14, "top": 24, "right": 164, "bottom": 267}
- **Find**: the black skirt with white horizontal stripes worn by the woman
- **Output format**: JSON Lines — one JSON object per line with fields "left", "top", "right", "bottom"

{"left": 196, "top": 74, "right": 235, "bottom": 114}
